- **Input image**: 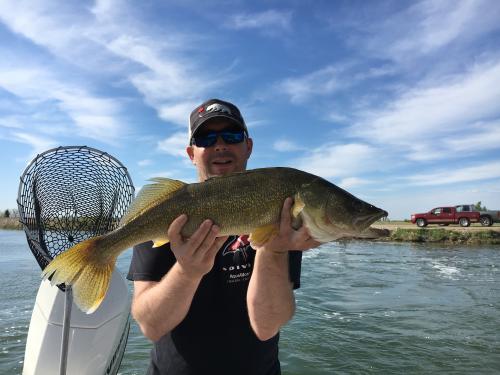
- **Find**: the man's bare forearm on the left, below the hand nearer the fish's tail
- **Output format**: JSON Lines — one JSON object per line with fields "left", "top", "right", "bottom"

{"left": 132, "top": 263, "right": 201, "bottom": 341}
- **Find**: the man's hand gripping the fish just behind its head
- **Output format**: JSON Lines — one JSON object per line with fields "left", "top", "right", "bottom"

{"left": 252, "top": 198, "right": 321, "bottom": 253}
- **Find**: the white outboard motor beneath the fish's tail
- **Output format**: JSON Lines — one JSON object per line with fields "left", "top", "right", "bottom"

{"left": 23, "top": 270, "right": 130, "bottom": 375}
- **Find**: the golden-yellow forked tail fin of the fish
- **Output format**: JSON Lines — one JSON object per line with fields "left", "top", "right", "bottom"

{"left": 42, "top": 236, "right": 116, "bottom": 314}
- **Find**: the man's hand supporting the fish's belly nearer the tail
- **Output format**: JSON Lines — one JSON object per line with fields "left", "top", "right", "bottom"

{"left": 167, "top": 214, "right": 228, "bottom": 278}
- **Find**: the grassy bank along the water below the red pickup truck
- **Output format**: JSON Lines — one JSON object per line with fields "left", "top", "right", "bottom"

{"left": 380, "top": 228, "right": 500, "bottom": 245}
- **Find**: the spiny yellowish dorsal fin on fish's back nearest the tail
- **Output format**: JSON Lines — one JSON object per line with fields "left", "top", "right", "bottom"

{"left": 120, "top": 177, "right": 186, "bottom": 225}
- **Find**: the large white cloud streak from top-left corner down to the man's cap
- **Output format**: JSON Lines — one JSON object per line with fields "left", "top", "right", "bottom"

{"left": 0, "top": 0, "right": 229, "bottom": 127}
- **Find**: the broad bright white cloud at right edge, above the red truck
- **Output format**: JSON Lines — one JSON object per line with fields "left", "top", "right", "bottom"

{"left": 352, "top": 62, "right": 500, "bottom": 160}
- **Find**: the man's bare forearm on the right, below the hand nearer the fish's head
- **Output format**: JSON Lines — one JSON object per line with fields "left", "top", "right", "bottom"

{"left": 247, "top": 251, "right": 295, "bottom": 340}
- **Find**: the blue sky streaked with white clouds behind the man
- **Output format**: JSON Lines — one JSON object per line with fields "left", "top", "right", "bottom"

{"left": 0, "top": 0, "right": 500, "bottom": 219}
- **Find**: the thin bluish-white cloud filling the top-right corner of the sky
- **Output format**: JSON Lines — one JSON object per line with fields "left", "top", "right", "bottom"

{"left": 351, "top": 0, "right": 500, "bottom": 62}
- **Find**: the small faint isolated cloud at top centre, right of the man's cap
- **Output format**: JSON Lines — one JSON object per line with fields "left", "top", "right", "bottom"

{"left": 225, "top": 9, "right": 292, "bottom": 34}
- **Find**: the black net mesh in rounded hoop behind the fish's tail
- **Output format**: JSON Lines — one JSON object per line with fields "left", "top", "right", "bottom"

{"left": 17, "top": 146, "right": 134, "bottom": 280}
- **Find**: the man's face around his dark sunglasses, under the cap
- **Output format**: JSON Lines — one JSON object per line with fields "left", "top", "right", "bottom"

{"left": 186, "top": 118, "right": 253, "bottom": 181}
